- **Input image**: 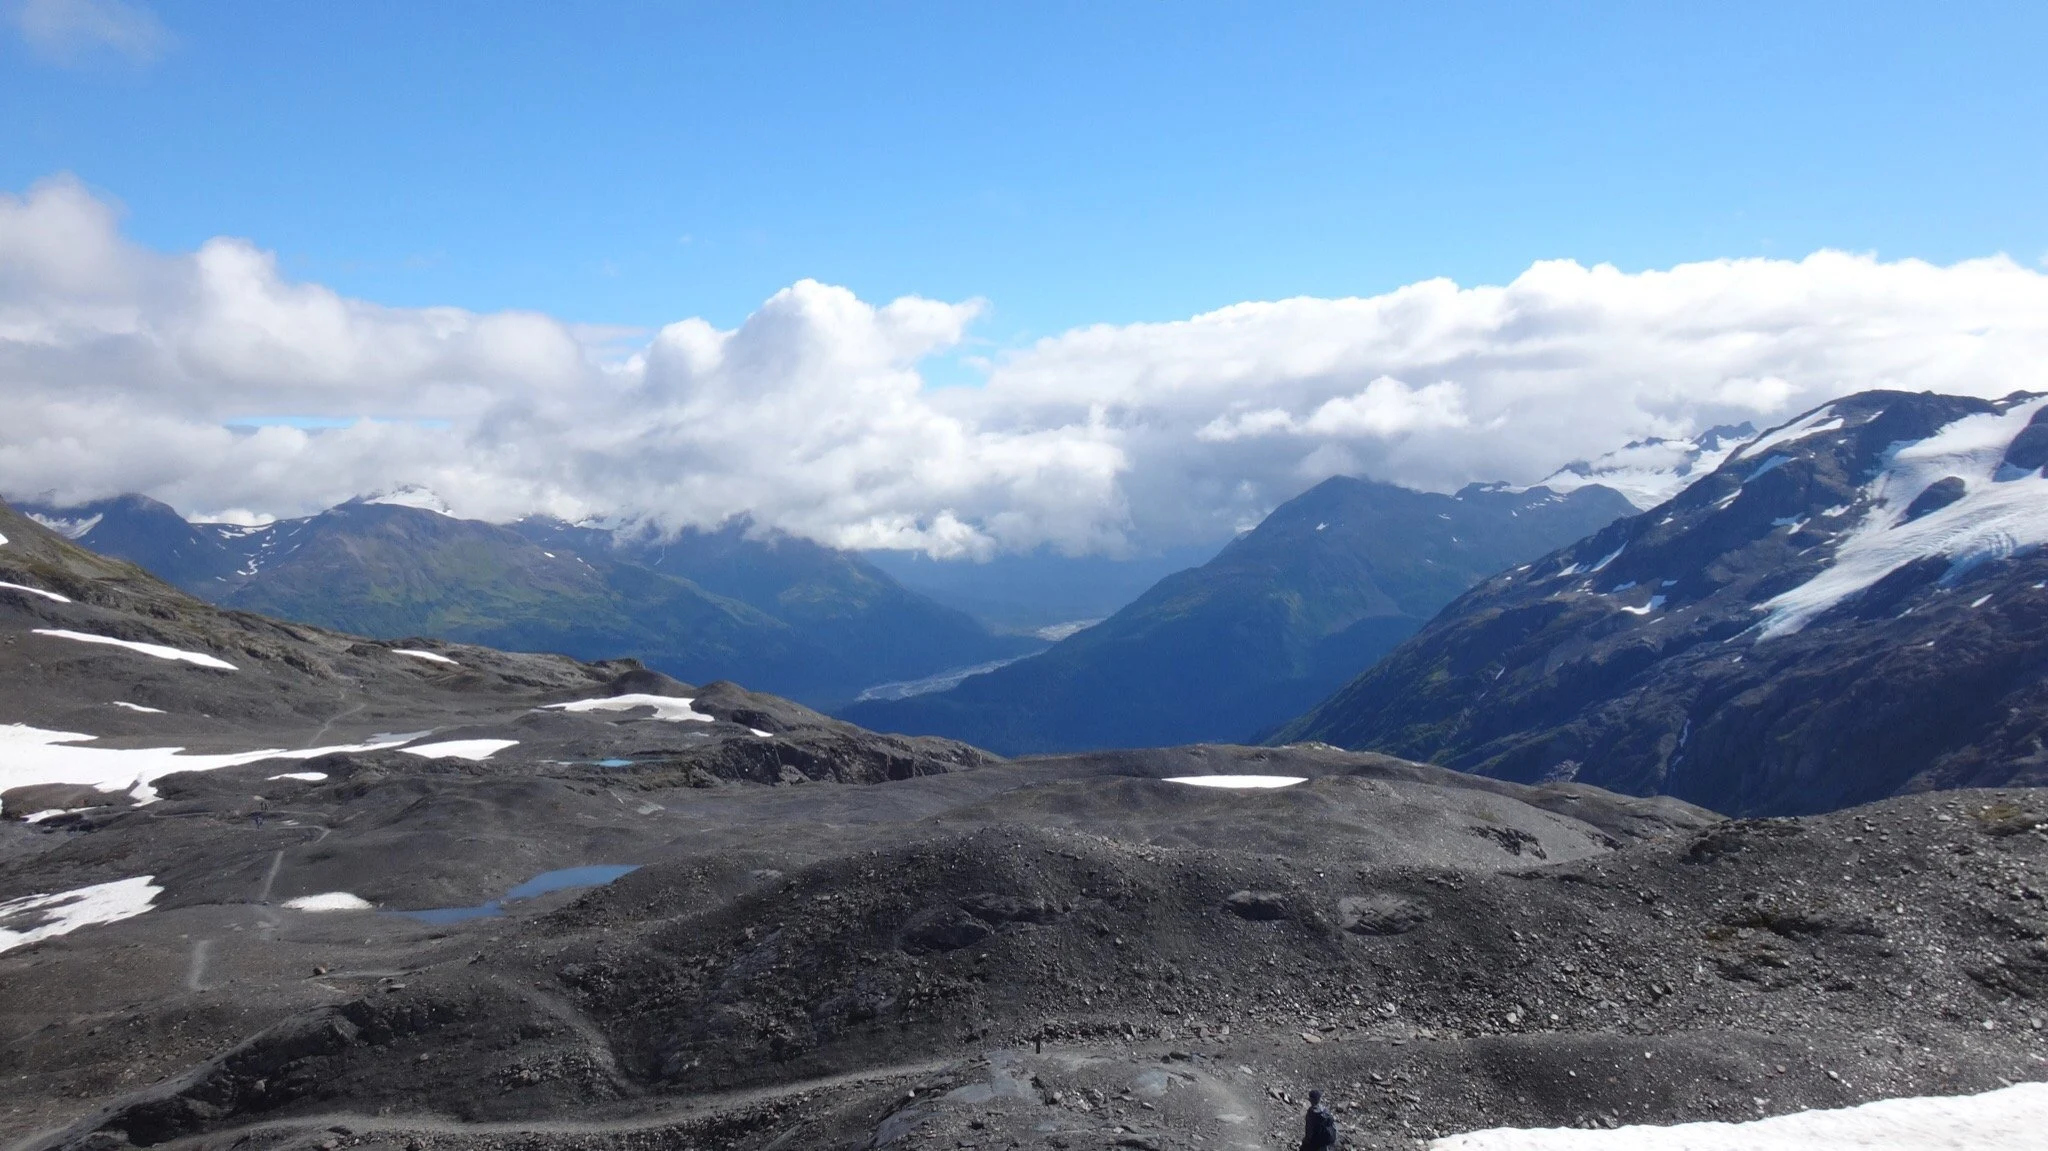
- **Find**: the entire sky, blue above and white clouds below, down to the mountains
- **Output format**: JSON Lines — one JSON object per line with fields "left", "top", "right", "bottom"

{"left": 12, "top": 0, "right": 2048, "bottom": 557}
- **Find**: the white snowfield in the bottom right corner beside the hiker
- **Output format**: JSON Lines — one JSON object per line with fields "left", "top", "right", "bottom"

{"left": 1430, "top": 1083, "right": 2048, "bottom": 1151}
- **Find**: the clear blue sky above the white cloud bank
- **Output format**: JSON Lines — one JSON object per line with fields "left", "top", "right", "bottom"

{"left": 0, "top": 0, "right": 2048, "bottom": 344}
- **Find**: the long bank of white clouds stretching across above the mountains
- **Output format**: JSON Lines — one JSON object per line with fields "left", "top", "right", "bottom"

{"left": 0, "top": 178, "right": 2048, "bottom": 555}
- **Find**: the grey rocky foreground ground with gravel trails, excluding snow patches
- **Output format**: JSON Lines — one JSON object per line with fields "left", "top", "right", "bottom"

{"left": 0, "top": 493, "right": 2048, "bottom": 1151}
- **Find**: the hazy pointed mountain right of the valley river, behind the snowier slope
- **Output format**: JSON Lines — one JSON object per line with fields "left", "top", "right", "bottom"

{"left": 838, "top": 477, "right": 1632, "bottom": 754}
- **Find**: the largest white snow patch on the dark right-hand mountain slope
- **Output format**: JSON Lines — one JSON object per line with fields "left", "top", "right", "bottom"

{"left": 1757, "top": 397, "right": 2048, "bottom": 639}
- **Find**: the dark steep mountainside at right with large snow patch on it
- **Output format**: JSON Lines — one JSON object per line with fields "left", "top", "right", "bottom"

{"left": 1278, "top": 391, "right": 2048, "bottom": 815}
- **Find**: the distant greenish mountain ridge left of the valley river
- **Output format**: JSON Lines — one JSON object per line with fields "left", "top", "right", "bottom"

{"left": 23, "top": 492, "right": 1042, "bottom": 707}
